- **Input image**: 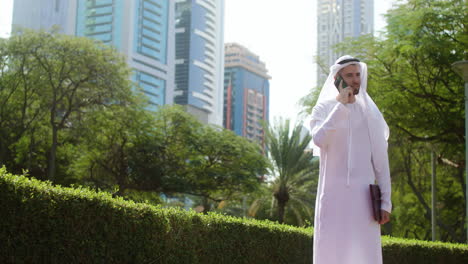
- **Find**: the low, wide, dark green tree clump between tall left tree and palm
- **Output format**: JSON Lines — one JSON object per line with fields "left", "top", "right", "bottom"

{"left": 76, "top": 106, "right": 267, "bottom": 210}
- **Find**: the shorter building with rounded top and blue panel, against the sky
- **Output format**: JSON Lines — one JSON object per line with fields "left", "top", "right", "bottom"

{"left": 223, "top": 43, "right": 271, "bottom": 146}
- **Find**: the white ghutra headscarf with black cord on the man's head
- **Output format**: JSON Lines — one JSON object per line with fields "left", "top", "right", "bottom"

{"left": 312, "top": 55, "right": 390, "bottom": 156}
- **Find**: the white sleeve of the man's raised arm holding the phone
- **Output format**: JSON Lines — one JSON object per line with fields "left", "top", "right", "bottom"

{"left": 310, "top": 102, "right": 349, "bottom": 149}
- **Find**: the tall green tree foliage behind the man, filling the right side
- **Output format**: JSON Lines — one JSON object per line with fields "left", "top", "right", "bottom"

{"left": 306, "top": 0, "right": 468, "bottom": 242}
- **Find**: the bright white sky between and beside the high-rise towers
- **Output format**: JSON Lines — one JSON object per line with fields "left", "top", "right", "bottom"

{"left": 0, "top": 0, "right": 395, "bottom": 124}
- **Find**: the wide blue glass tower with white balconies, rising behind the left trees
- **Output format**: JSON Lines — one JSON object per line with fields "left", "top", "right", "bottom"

{"left": 76, "top": 0, "right": 174, "bottom": 110}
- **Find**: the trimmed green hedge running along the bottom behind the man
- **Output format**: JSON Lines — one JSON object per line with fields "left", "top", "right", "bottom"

{"left": 0, "top": 168, "right": 468, "bottom": 264}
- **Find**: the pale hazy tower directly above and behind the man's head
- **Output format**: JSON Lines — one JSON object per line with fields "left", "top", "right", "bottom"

{"left": 317, "top": 0, "right": 374, "bottom": 85}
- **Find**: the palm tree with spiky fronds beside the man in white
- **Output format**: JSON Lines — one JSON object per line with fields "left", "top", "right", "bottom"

{"left": 250, "top": 119, "right": 317, "bottom": 225}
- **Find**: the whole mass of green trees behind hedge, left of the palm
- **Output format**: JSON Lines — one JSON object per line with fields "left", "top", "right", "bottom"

{"left": 0, "top": 30, "right": 267, "bottom": 210}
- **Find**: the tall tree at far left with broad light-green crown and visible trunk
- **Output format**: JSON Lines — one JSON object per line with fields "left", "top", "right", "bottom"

{"left": 1, "top": 30, "right": 132, "bottom": 180}
